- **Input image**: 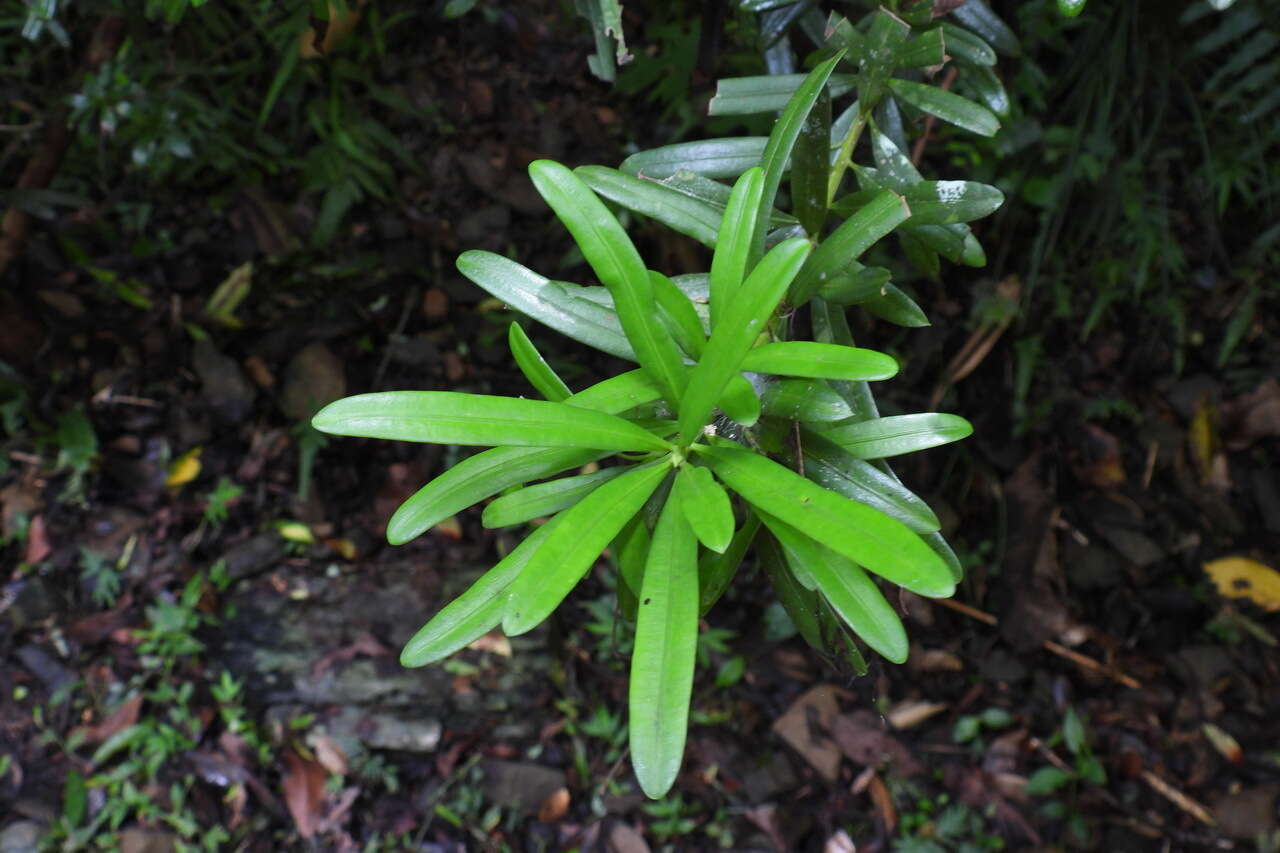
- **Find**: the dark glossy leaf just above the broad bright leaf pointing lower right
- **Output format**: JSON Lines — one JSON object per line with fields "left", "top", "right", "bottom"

{"left": 801, "top": 430, "right": 942, "bottom": 533}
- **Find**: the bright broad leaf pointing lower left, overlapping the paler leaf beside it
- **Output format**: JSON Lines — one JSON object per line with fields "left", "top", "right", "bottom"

{"left": 502, "top": 464, "right": 671, "bottom": 637}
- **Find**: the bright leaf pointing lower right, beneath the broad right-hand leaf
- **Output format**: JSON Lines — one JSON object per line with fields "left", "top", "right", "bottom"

{"left": 764, "top": 517, "right": 910, "bottom": 663}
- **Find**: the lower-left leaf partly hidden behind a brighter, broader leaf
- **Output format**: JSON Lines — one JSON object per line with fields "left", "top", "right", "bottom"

{"left": 401, "top": 519, "right": 562, "bottom": 666}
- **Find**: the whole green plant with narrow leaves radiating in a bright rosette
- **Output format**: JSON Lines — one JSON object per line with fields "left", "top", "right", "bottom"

{"left": 314, "top": 3, "right": 1007, "bottom": 797}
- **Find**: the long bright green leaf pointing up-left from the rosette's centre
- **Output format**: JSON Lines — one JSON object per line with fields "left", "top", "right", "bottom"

{"left": 529, "top": 160, "right": 685, "bottom": 400}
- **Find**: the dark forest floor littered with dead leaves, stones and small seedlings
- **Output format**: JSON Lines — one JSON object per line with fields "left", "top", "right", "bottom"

{"left": 0, "top": 6, "right": 1280, "bottom": 853}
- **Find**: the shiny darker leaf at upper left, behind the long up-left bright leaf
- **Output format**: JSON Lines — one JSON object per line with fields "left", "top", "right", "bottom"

{"left": 457, "top": 250, "right": 636, "bottom": 361}
